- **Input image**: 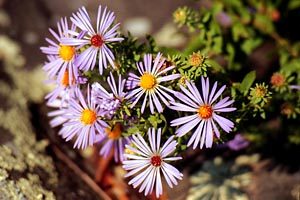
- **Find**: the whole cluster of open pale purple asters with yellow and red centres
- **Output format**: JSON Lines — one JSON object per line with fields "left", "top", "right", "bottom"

{"left": 41, "top": 6, "right": 236, "bottom": 197}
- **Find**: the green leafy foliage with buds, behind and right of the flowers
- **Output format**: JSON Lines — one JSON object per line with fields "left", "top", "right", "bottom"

{"left": 89, "top": 0, "right": 300, "bottom": 149}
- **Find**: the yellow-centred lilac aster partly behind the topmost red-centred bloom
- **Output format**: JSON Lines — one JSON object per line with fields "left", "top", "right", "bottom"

{"left": 41, "top": 18, "right": 78, "bottom": 83}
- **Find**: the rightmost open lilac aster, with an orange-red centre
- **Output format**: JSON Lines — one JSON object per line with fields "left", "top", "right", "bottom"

{"left": 170, "top": 77, "right": 236, "bottom": 149}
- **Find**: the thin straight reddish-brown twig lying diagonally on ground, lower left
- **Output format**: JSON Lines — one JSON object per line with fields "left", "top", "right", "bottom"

{"left": 51, "top": 144, "right": 111, "bottom": 200}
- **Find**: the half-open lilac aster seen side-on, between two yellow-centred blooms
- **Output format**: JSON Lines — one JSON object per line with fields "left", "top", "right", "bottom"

{"left": 92, "top": 73, "right": 126, "bottom": 118}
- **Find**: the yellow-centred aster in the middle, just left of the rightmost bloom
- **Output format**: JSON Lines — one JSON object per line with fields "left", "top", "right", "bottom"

{"left": 126, "top": 53, "right": 180, "bottom": 113}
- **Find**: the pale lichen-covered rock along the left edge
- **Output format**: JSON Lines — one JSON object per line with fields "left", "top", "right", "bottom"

{"left": 0, "top": 36, "right": 58, "bottom": 199}
